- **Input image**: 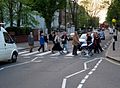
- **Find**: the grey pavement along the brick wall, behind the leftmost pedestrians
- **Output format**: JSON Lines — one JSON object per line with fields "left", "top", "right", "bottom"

{"left": 16, "top": 41, "right": 39, "bottom": 50}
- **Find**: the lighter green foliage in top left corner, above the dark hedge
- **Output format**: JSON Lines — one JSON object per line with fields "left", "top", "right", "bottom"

{"left": 0, "top": 0, "right": 39, "bottom": 27}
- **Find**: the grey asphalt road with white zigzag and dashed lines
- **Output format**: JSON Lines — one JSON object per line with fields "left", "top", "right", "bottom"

{"left": 0, "top": 29, "right": 120, "bottom": 88}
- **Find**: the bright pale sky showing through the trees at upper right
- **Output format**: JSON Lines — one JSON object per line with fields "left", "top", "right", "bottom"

{"left": 78, "top": 0, "right": 110, "bottom": 23}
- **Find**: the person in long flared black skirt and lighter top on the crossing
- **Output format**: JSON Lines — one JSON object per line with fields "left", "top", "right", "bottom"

{"left": 52, "top": 32, "right": 63, "bottom": 54}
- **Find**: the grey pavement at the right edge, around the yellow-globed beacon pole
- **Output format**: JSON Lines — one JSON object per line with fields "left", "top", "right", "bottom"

{"left": 106, "top": 32, "right": 120, "bottom": 62}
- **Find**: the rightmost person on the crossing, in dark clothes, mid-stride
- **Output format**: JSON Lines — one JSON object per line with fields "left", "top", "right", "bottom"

{"left": 93, "top": 32, "right": 103, "bottom": 53}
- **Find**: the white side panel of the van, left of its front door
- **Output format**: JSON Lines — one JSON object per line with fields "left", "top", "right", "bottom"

{"left": 0, "top": 32, "right": 6, "bottom": 61}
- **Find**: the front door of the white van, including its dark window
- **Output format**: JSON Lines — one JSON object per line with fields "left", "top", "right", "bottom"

{"left": 3, "top": 32, "right": 15, "bottom": 59}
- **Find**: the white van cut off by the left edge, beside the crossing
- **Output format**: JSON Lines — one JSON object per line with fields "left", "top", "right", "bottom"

{"left": 0, "top": 26, "right": 18, "bottom": 62}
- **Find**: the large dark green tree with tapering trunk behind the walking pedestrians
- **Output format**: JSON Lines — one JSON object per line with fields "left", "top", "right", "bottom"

{"left": 22, "top": 0, "right": 65, "bottom": 32}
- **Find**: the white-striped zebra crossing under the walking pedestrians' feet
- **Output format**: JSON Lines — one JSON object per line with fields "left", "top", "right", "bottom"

{"left": 19, "top": 50, "right": 81, "bottom": 57}
